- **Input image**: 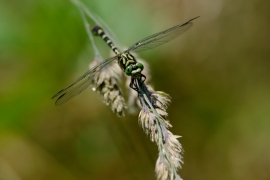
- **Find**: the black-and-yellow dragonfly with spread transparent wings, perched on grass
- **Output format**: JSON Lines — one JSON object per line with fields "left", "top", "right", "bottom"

{"left": 52, "top": 16, "right": 199, "bottom": 106}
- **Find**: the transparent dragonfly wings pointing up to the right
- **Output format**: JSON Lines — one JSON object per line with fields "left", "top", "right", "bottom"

{"left": 125, "top": 16, "right": 199, "bottom": 52}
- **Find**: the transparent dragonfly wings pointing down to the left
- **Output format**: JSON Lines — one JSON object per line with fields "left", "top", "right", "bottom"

{"left": 52, "top": 56, "right": 117, "bottom": 106}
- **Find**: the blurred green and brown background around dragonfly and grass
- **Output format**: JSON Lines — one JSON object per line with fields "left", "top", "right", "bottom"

{"left": 0, "top": 0, "right": 270, "bottom": 180}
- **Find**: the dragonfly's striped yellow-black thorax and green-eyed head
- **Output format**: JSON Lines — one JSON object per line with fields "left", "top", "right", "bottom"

{"left": 118, "top": 52, "right": 144, "bottom": 78}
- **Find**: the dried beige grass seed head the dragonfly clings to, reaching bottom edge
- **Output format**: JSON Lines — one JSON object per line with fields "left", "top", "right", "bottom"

{"left": 138, "top": 82, "right": 183, "bottom": 180}
